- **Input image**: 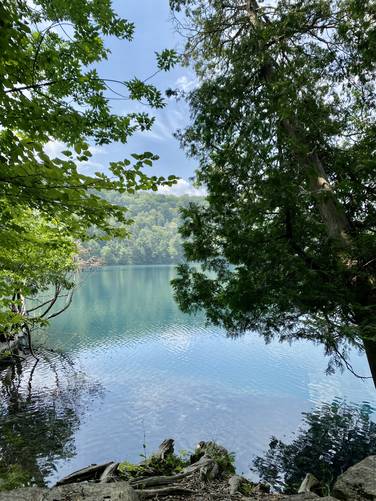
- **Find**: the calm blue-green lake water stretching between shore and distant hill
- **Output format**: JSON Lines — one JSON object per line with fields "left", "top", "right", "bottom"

{"left": 0, "top": 266, "right": 375, "bottom": 482}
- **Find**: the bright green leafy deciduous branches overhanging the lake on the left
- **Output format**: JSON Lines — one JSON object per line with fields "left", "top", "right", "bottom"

{"left": 0, "top": 0, "right": 177, "bottom": 336}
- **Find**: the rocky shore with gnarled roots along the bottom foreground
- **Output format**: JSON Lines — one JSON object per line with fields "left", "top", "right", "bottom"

{"left": 0, "top": 439, "right": 376, "bottom": 501}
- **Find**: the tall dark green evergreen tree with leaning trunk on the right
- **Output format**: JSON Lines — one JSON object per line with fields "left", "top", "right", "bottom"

{"left": 171, "top": 0, "right": 376, "bottom": 382}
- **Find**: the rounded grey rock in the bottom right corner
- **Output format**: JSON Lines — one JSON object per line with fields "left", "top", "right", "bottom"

{"left": 333, "top": 456, "right": 376, "bottom": 501}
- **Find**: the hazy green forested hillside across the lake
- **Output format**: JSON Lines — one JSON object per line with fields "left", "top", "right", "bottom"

{"left": 84, "top": 193, "right": 203, "bottom": 264}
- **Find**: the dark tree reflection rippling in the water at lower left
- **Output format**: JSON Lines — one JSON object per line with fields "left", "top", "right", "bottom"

{"left": 0, "top": 353, "right": 100, "bottom": 490}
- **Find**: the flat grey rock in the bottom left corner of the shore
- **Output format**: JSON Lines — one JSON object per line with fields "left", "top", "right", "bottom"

{"left": 0, "top": 482, "right": 139, "bottom": 501}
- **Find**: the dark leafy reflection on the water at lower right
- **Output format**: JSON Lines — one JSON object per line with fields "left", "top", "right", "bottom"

{"left": 253, "top": 401, "right": 376, "bottom": 495}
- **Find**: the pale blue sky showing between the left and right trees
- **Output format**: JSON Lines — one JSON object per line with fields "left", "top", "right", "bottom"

{"left": 87, "top": 0, "right": 201, "bottom": 193}
